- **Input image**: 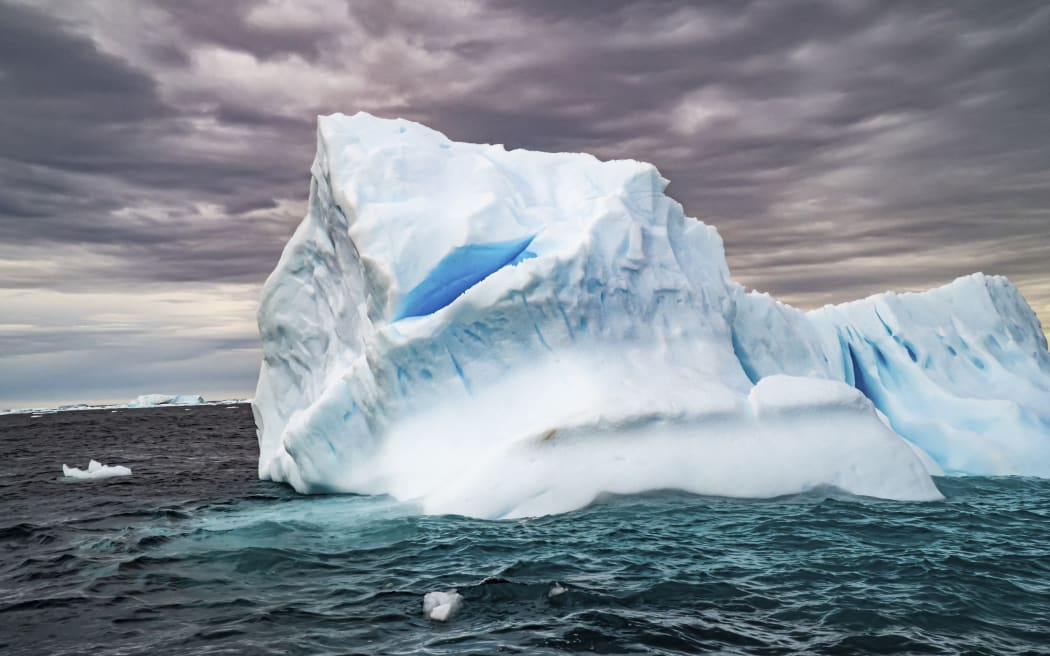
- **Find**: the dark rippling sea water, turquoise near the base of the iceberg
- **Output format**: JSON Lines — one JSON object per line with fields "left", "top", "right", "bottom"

{"left": 0, "top": 405, "right": 1050, "bottom": 655}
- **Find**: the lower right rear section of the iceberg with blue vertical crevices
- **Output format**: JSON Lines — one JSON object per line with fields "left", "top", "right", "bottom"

{"left": 734, "top": 274, "right": 1050, "bottom": 477}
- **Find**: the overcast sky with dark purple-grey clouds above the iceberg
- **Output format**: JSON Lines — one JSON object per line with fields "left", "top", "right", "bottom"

{"left": 0, "top": 0, "right": 1050, "bottom": 407}
